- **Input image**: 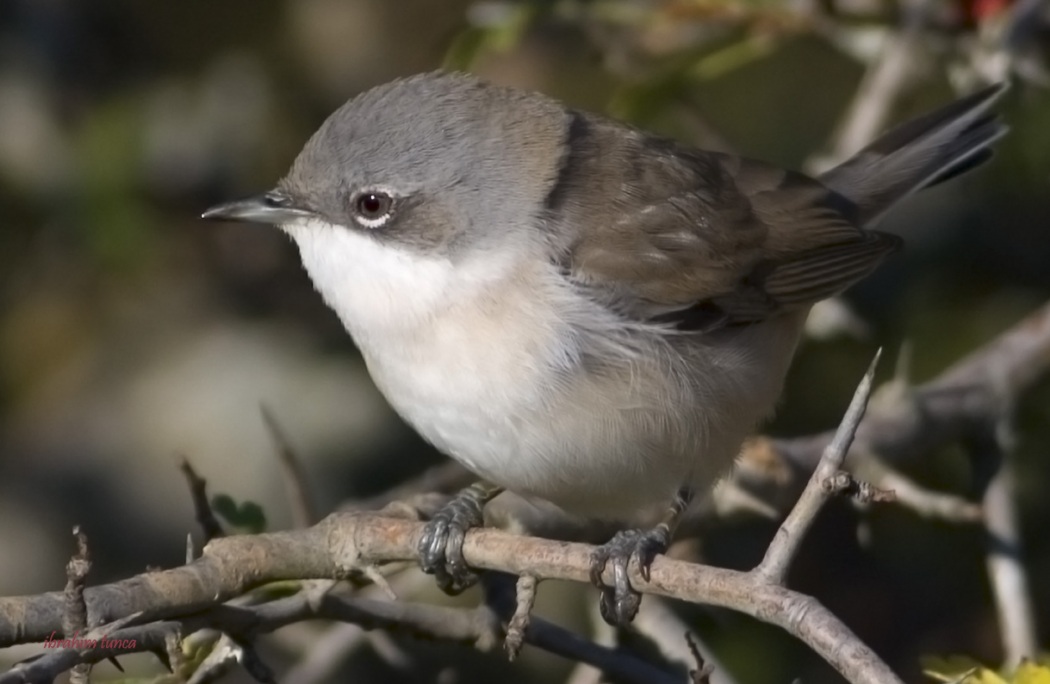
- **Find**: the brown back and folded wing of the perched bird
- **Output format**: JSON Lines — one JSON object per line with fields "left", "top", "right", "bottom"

{"left": 548, "top": 115, "right": 899, "bottom": 330}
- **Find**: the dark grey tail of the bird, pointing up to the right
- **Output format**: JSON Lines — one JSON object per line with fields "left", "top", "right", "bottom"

{"left": 820, "top": 83, "right": 1009, "bottom": 225}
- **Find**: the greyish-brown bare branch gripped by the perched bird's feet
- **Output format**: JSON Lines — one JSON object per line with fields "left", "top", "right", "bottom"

{"left": 0, "top": 513, "right": 898, "bottom": 684}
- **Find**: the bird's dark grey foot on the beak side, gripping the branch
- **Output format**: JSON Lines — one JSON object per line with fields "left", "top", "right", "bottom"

{"left": 417, "top": 482, "right": 503, "bottom": 596}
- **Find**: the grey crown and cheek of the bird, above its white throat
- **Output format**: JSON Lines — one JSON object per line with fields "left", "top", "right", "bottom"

{"left": 279, "top": 72, "right": 569, "bottom": 254}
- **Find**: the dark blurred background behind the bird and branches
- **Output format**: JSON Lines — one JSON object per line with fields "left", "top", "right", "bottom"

{"left": 0, "top": 0, "right": 1050, "bottom": 683}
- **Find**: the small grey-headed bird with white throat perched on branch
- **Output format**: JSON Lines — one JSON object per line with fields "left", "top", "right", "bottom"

{"left": 204, "top": 72, "right": 1006, "bottom": 623}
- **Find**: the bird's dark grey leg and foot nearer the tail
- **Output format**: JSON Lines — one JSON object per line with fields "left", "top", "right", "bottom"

{"left": 590, "top": 488, "right": 693, "bottom": 626}
